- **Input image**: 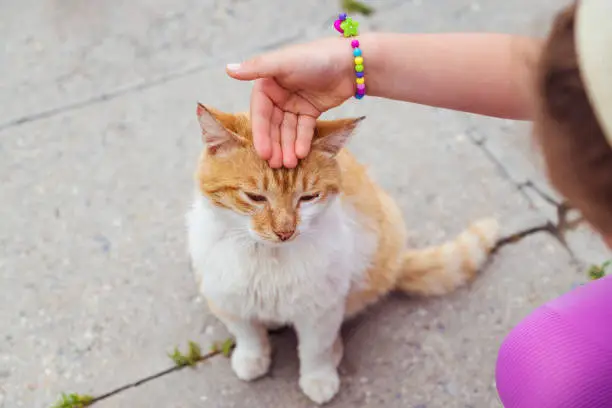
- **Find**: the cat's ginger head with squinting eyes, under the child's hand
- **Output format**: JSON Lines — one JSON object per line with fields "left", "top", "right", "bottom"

{"left": 197, "top": 104, "right": 361, "bottom": 244}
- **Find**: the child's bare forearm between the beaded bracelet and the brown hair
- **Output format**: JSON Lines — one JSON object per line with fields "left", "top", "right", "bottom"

{"left": 359, "top": 33, "right": 542, "bottom": 119}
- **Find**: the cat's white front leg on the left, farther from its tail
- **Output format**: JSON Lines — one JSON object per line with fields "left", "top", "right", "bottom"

{"left": 208, "top": 302, "right": 271, "bottom": 381}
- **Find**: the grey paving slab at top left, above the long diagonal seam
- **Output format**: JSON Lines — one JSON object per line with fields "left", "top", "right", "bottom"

{"left": 0, "top": 0, "right": 336, "bottom": 125}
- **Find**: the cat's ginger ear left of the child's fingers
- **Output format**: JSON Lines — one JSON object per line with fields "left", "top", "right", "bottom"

{"left": 197, "top": 103, "right": 243, "bottom": 155}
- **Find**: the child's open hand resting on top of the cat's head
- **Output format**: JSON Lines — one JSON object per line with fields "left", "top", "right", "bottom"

{"left": 227, "top": 38, "right": 355, "bottom": 168}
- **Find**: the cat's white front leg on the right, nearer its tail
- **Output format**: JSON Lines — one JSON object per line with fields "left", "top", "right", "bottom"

{"left": 294, "top": 305, "right": 344, "bottom": 404}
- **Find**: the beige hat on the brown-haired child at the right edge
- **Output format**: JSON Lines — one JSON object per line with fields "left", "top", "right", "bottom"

{"left": 575, "top": 0, "right": 612, "bottom": 145}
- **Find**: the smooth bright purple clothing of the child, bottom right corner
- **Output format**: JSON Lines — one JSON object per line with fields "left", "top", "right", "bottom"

{"left": 496, "top": 276, "right": 612, "bottom": 408}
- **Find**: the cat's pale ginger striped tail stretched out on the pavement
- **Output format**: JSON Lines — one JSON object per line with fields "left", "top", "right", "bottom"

{"left": 397, "top": 218, "right": 499, "bottom": 296}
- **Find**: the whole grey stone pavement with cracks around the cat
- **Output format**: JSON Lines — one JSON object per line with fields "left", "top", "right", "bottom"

{"left": 0, "top": 0, "right": 607, "bottom": 408}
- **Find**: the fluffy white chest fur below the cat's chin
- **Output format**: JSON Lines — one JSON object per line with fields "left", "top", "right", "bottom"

{"left": 187, "top": 195, "right": 377, "bottom": 323}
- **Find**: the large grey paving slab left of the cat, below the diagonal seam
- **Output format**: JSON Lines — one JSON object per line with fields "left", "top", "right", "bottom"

{"left": 0, "top": 68, "right": 232, "bottom": 407}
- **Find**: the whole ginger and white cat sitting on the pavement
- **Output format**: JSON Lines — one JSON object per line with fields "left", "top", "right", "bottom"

{"left": 187, "top": 105, "right": 498, "bottom": 404}
